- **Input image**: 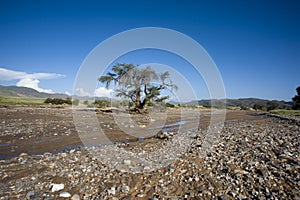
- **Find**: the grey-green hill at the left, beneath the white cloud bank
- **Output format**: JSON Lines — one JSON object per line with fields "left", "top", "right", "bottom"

{"left": 0, "top": 85, "right": 68, "bottom": 99}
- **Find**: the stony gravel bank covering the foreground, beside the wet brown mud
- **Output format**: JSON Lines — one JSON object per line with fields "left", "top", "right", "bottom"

{"left": 0, "top": 110, "right": 300, "bottom": 200}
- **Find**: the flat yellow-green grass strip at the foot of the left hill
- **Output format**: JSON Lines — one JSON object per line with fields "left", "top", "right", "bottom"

{"left": 0, "top": 96, "right": 45, "bottom": 105}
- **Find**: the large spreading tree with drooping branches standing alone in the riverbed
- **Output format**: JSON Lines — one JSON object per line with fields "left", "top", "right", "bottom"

{"left": 99, "top": 63, "right": 177, "bottom": 111}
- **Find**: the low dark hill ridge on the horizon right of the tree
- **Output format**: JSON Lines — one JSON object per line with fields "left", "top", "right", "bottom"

{"left": 184, "top": 98, "right": 292, "bottom": 108}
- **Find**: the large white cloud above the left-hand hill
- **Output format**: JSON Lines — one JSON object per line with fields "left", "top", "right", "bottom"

{"left": 0, "top": 68, "right": 65, "bottom": 93}
